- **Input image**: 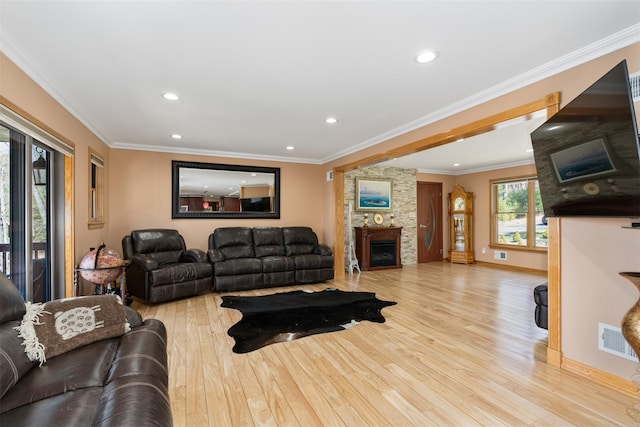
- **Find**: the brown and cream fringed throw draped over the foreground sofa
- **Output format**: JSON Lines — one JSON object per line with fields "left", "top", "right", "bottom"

{"left": 16, "top": 295, "right": 131, "bottom": 366}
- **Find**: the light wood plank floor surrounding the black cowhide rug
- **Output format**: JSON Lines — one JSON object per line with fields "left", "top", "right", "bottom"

{"left": 133, "top": 263, "right": 637, "bottom": 427}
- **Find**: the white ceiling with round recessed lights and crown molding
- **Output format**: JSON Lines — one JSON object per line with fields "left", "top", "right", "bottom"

{"left": 0, "top": 0, "right": 640, "bottom": 173}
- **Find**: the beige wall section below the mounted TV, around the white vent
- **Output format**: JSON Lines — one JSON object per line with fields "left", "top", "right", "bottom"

{"left": 560, "top": 218, "right": 640, "bottom": 379}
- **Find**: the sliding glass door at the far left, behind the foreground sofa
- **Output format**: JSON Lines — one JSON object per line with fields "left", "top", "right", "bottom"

{"left": 0, "top": 122, "right": 55, "bottom": 302}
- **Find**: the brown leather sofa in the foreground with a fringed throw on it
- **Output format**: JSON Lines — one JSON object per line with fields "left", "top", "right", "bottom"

{"left": 0, "top": 275, "right": 173, "bottom": 427}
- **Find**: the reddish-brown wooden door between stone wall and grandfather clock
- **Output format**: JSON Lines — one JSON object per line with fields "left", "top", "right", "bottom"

{"left": 417, "top": 182, "right": 443, "bottom": 262}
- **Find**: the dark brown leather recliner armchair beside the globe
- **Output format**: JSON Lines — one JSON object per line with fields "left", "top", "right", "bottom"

{"left": 122, "top": 229, "right": 213, "bottom": 304}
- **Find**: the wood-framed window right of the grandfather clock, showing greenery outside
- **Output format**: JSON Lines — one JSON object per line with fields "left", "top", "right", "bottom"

{"left": 491, "top": 177, "right": 548, "bottom": 250}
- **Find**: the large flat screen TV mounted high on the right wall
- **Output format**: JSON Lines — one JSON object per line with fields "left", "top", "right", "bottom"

{"left": 531, "top": 61, "right": 640, "bottom": 218}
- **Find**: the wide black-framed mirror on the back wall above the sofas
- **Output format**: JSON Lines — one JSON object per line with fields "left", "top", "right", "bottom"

{"left": 171, "top": 160, "right": 280, "bottom": 219}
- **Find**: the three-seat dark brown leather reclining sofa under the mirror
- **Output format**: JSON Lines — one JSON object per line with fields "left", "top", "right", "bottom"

{"left": 207, "top": 227, "right": 334, "bottom": 291}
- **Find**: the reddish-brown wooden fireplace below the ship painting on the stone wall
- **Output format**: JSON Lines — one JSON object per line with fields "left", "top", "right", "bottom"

{"left": 355, "top": 227, "right": 402, "bottom": 271}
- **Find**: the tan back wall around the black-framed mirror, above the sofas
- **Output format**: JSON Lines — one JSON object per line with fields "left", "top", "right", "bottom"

{"left": 107, "top": 149, "right": 324, "bottom": 251}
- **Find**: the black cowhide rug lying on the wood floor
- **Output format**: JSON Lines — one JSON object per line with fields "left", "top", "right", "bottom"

{"left": 221, "top": 288, "right": 396, "bottom": 353}
